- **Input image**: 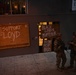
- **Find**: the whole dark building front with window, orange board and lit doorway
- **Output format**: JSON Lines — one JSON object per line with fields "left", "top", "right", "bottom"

{"left": 0, "top": 0, "right": 76, "bottom": 57}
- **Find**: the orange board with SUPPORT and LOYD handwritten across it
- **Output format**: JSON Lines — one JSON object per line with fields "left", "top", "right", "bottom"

{"left": 0, "top": 23, "right": 30, "bottom": 49}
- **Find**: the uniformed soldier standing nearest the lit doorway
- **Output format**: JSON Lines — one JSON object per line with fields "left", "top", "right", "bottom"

{"left": 54, "top": 33, "right": 66, "bottom": 70}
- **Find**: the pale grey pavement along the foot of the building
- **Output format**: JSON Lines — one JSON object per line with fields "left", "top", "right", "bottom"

{"left": 0, "top": 52, "right": 76, "bottom": 75}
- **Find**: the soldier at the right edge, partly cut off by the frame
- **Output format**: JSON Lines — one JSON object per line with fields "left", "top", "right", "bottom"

{"left": 68, "top": 32, "right": 76, "bottom": 69}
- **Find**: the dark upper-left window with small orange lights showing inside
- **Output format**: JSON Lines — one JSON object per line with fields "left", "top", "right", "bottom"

{"left": 0, "top": 0, "right": 27, "bottom": 15}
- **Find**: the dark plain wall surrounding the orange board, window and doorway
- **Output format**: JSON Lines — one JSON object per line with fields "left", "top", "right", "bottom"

{"left": 0, "top": 0, "right": 76, "bottom": 56}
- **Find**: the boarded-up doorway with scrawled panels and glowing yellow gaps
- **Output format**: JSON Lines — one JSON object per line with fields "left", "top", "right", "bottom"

{"left": 38, "top": 21, "right": 60, "bottom": 53}
